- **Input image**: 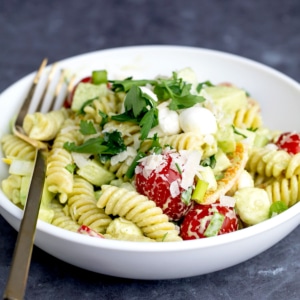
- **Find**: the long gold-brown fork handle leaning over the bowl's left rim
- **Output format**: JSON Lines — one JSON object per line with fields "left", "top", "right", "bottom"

{"left": 3, "top": 149, "right": 46, "bottom": 300}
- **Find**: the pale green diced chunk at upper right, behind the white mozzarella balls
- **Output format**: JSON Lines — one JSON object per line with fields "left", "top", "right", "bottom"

{"left": 204, "top": 85, "right": 248, "bottom": 113}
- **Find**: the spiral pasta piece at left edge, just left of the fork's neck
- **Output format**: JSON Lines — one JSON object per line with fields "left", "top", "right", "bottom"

{"left": 1, "top": 134, "right": 35, "bottom": 160}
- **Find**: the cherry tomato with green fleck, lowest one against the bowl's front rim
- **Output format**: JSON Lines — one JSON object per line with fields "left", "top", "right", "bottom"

{"left": 180, "top": 203, "right": 239, "bottom": 240}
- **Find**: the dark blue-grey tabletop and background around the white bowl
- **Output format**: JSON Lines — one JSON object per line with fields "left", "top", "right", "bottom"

{"left": 0, "top": 0, "right": 300, "bottom": 300}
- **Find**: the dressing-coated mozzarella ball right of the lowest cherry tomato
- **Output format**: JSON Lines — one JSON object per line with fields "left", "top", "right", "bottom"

{"left": 233, "top": 187, "right": 271, "bottom": 225}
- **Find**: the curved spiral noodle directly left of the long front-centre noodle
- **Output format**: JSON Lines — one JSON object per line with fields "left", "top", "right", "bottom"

{"left": 67, "top": 175, "right": 111, "bottom": 233}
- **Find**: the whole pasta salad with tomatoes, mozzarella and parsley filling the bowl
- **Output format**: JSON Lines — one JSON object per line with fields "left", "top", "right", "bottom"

{"left": 1, "top": 68, "right": 300, "bottom": 242}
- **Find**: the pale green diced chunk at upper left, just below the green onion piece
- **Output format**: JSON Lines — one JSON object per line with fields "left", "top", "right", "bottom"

{"left": 71, "top": 82, "right": 107, "bottom": 111}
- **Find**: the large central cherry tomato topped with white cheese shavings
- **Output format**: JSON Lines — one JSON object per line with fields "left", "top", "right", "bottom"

{"left": 135, "top": 152, "right": 191, "bottom": 221}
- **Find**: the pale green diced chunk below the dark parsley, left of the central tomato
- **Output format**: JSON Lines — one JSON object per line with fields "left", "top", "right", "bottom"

{"left": 77, "top": 159, "right": 115, "bottom": 186}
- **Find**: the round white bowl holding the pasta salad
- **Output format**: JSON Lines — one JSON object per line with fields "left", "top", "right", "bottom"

{"left": 0, "top": 46, "right": 300, "bottom": 279}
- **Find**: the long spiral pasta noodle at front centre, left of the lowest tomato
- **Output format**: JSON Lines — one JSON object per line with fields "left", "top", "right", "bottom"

{"left": 97, "top": 185, "right": 181, "bottom": 242}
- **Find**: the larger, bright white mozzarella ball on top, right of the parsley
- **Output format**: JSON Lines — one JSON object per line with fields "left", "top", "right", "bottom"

{"left": 179, "top": 106, "right": 217, "bottom": 135}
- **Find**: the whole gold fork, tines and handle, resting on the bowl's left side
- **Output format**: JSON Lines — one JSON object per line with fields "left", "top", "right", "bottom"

{"left": 3, "top": 59, "right": 64, "bottom": 299}
